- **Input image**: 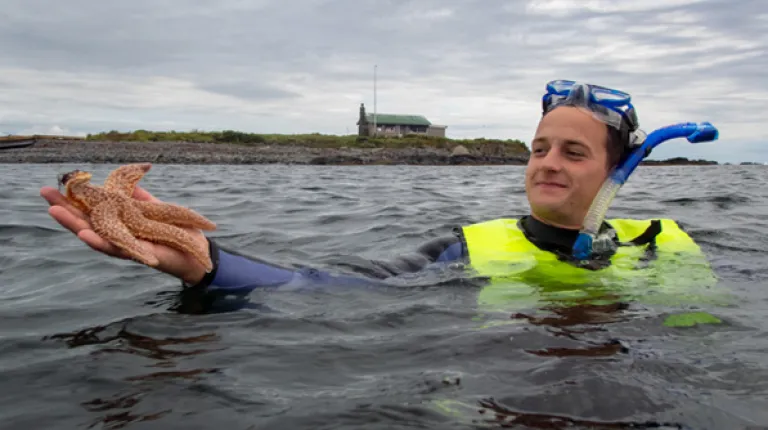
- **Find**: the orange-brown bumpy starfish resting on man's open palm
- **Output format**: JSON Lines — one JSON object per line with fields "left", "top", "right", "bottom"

{"left": 59, "top": 163, "right": 216, "bottom": 272}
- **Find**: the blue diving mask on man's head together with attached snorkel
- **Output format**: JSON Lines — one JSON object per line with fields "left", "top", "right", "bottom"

{"left": 542, "top": 80, "right": 719, "bottom": 260}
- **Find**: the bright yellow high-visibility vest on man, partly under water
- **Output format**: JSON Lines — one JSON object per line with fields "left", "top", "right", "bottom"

{"left": 461, "top": 218, "right": 717, "bottom": 308}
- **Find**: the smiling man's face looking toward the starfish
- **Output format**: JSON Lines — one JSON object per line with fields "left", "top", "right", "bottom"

{"left": 525, "top": 106, "right": 608, "bottom": 228}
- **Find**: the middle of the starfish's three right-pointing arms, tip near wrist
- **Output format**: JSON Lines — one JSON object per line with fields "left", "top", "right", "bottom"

{"left": 122, "top": 202, "right": 213, "bottom": 272}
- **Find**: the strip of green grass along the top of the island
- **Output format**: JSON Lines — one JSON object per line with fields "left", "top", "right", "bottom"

{"left": 86, "top": 130, "right": 529, "bottom": 154}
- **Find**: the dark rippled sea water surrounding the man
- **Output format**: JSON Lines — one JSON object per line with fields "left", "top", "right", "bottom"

{"left": 0, "top": 164, "right": 768, "bottom": 430}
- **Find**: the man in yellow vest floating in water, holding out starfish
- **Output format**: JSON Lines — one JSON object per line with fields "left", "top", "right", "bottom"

{"left": 41, "top": 81, "right": 716, "bottom": 316}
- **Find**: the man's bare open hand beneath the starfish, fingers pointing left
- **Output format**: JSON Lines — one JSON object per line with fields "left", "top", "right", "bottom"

{"left": 40, "top": 186, "right": 208, "bottom": 284}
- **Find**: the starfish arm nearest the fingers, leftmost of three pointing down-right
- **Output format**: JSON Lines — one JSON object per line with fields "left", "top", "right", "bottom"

{"left": 90, "top": 200, "right": 159, "bottom": 267}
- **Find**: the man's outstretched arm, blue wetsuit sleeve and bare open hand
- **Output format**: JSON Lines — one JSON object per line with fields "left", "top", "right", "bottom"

{"left": 40, "top": 181, "right": 465, "bottom": 312}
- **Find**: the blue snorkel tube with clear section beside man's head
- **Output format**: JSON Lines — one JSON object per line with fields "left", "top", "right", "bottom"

{"left": 573, "top": 122, "right": 719, "bottom": 260}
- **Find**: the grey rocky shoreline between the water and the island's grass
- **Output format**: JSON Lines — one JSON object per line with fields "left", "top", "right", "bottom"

{"left": 0, "top": 139, "right": 528, "bottom": 165}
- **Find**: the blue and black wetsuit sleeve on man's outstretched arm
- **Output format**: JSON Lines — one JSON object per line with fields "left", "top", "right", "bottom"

{"left": 185, "top": 235, "right": 465, "bottom": 312}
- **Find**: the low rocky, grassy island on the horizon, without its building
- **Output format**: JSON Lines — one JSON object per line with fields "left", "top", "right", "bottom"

{"left": 0, "top": 130, "right": 717, "bottom": 166}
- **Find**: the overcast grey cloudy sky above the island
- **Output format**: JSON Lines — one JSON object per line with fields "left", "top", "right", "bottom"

{"left": 0, "top": 0, "right": 768, "bottom": 162}
